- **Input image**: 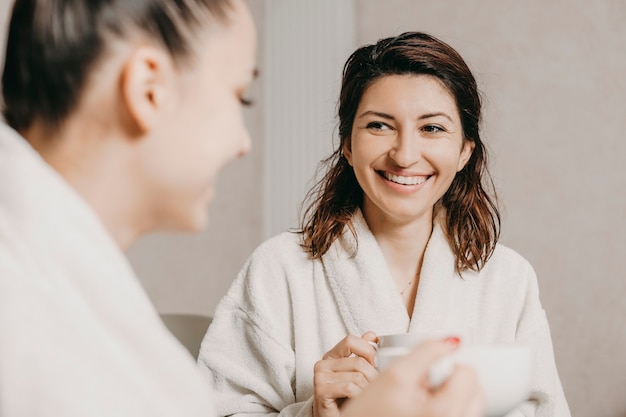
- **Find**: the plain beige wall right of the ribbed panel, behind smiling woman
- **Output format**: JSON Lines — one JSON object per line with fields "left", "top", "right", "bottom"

{"left": 356, "top": 0, "right": 626, "bottom": 417}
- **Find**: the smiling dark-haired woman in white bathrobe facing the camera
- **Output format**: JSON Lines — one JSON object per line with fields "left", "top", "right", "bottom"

{"left": 199, "top": 32, "right": 570, "bottom": 417}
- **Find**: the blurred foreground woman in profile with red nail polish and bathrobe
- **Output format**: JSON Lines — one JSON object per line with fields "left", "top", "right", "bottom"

{"left": 0, "top": 0, "right": 480, "bottom": 417}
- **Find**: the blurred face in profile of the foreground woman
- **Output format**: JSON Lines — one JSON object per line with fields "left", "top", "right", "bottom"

{"left": 141, "top": 0, "right": 256, "bottom": 231}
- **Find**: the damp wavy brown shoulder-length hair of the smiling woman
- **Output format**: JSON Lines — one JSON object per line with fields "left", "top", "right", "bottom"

{"left": 300, "top": 32, "right": 500, "bottom": 272}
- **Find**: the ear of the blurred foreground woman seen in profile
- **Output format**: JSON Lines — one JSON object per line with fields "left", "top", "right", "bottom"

{"left": 121, "top": 46, "right": 173, "bottom": 133}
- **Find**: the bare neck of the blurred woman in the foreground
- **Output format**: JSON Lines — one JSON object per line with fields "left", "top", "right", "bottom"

{"left": 21, "top": 123, "right": 150, "bottom": 250}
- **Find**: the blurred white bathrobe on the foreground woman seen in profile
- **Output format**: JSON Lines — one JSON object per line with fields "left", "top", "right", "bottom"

{"left": 0, "top": 124, "right": 214, "bottom": 417}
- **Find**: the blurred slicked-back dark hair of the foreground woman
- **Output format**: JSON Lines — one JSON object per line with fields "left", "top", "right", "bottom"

{"left": 2, "top": 0, "right": 231, "bottom": 131}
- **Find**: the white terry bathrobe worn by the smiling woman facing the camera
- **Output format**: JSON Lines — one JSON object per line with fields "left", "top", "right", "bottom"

{"left": 198, "top": 212, "right": 570, "bottom": 417}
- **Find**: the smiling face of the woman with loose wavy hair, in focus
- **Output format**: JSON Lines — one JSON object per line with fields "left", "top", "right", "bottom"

{"left": 344, "top": 75, "right": 473, "bottom": 228}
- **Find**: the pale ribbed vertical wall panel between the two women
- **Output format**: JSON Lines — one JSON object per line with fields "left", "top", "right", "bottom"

{"left": 260, "top": 0, "right": 356, "bottom": 238}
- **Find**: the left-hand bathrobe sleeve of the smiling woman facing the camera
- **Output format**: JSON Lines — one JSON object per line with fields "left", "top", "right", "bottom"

{"left": 198, "top": 234, "right": 312, "bottom": 417}
